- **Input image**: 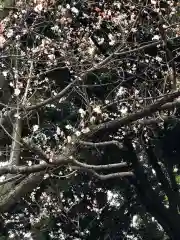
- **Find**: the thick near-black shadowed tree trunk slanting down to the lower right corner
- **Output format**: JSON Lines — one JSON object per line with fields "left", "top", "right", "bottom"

{"left": 125, "top": 139, "right": 180, "bottom": 240}
